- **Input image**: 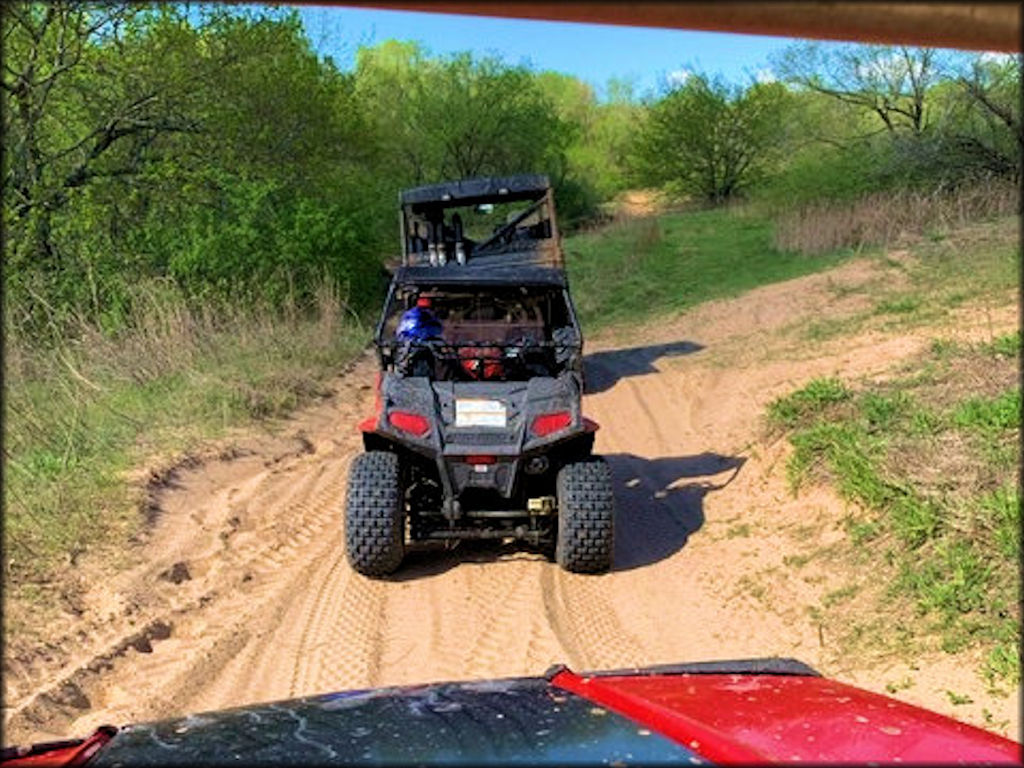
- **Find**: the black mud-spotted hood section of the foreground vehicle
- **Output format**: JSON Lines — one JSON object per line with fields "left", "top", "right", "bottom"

{"left": 90, "top": 678, "right": 702, "bottom": 766}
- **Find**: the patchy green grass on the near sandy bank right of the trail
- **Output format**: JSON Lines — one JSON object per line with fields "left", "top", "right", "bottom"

{"left": 767, "top": 336, "right": 1021, "bottom": 684}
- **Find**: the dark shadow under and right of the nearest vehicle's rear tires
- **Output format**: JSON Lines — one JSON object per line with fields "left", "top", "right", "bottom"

{"left": 387, "top": 454, "right": 746, "bottom": 582}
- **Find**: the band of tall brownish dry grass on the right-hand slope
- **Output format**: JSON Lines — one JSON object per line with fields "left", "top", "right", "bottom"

{"left": 774, "top": 178, "right": 1021, "bottom": 254}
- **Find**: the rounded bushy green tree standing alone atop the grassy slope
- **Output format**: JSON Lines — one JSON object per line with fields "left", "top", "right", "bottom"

{"left": 632, "top": 74, "right": 787, "bottom": 204}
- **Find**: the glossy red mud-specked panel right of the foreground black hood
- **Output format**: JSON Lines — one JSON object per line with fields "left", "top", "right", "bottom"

{"left": 551, "top": 671, "right": 1021, "bottom": 764}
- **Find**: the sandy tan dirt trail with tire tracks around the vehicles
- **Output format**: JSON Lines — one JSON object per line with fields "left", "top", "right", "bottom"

{"left": 5, "top": 257, "right": 1019, "bottom": 742}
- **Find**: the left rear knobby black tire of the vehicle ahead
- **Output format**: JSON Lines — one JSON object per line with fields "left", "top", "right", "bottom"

{"left": 345, "top": 451, "right": 406, "bottom": 577}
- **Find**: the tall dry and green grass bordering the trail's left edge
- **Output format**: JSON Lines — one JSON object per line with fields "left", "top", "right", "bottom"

{"left": 3, "top": 281, "right": 369, "bottom": 588}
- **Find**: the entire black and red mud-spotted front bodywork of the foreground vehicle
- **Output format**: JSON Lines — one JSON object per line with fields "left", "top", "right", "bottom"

{"left": 4, "top": 658, "right": 1021, "bottom": 768}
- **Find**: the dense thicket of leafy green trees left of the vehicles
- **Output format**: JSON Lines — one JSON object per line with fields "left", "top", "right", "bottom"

{"left": 3, "top": 1, "right": 385, "bottom": 328}
